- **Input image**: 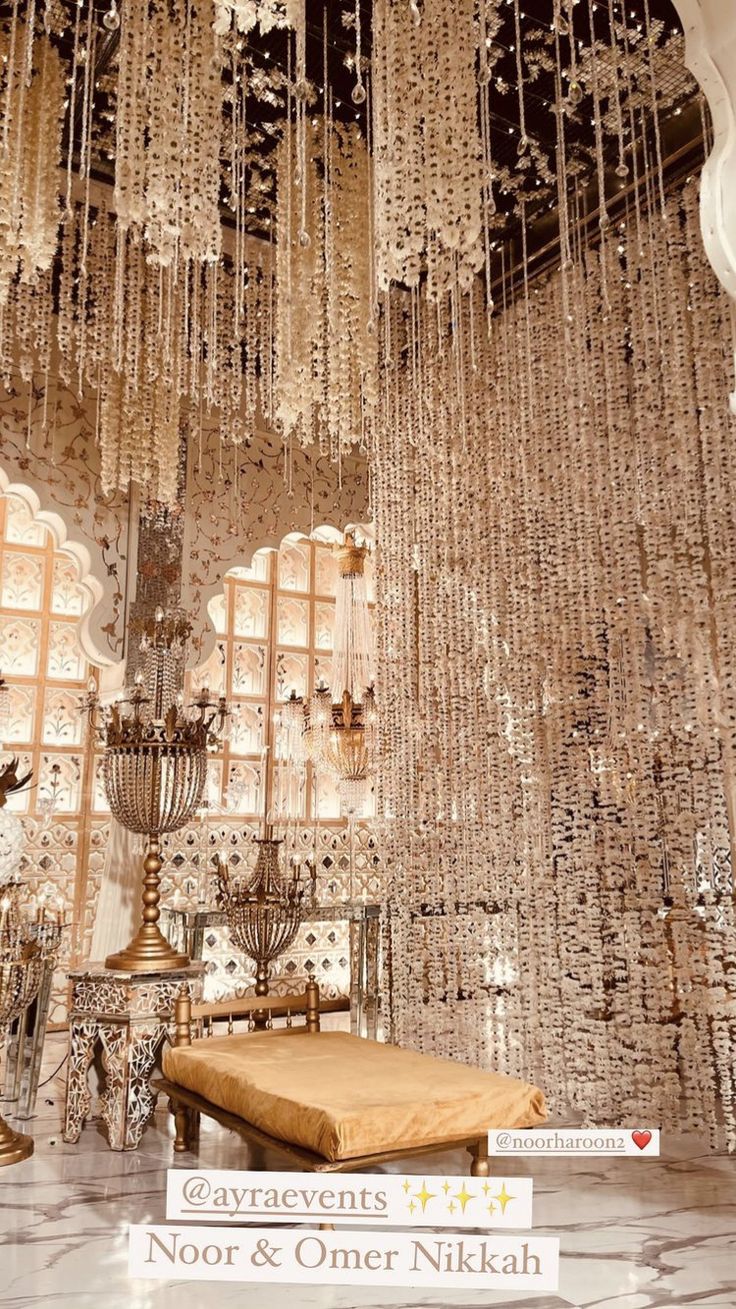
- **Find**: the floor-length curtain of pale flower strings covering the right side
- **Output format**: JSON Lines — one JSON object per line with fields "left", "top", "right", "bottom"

{"left": 373, "top": 185, "right": 736, "bottom": 1147}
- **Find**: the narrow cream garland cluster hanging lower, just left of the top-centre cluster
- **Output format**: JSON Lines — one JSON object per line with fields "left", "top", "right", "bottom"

{"left": 274, "top": 115, "right": 377, "bottom": 456}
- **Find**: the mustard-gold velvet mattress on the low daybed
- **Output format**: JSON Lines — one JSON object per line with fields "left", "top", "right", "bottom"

{"left": 164, "top": 1028, "right": 546, "bottom": 1162}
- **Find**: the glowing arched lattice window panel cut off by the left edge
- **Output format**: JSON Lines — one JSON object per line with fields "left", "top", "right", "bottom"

{"left": 0, "top": 492, "right": 109, "bottom": 1024}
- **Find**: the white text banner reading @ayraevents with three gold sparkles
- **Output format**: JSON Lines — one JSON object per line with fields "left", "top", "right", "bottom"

{"left": 166, "top": 1168, "right": 532, "bottom": 1228}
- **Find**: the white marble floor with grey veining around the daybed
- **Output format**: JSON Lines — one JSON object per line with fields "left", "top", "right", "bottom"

{"left": 0, "top": 1038, "right": 736, "bottom": 1309}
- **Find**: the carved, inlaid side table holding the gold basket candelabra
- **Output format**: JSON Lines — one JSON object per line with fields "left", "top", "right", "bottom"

{"left": 64, "top": 963, "right": 204, "bottom": 1149}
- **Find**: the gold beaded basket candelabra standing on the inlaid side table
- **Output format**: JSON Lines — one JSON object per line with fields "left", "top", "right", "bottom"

{"left": 84, "top": 609, "right": 228, "bottom": 973}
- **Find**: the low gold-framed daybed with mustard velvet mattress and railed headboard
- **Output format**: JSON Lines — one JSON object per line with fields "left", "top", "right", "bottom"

{"left": 157, "top": 979, "right": 546, "bottom": 1175}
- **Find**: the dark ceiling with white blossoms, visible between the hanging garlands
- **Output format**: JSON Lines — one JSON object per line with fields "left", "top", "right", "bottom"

{"left": 0, "top": 0, "right": 701, "bottom": 278}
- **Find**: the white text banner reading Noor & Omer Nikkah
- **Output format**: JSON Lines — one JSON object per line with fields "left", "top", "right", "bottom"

{"left": 128, "top": 1224, "right": 559, "bottom": 1293}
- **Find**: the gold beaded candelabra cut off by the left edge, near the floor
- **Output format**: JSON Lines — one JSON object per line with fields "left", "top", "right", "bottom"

{"left": 0, "top": 882, "right": 63, "bottom": 1168}
